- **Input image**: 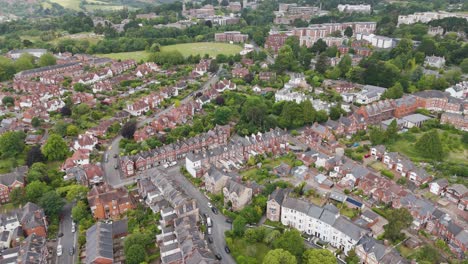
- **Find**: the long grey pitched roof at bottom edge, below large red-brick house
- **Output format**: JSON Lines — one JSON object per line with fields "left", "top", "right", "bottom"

{"left": 86, "top": 222, "right": 114, "bottom": 264}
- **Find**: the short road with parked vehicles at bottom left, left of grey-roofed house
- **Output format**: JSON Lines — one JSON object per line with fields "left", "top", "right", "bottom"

{"left": 55, "top": 203, "right": 78, "bottom": 264}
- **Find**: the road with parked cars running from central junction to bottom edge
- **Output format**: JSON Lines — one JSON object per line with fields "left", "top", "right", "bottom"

{"left": 167, "top": 166, "right": 236, "bottom": 264}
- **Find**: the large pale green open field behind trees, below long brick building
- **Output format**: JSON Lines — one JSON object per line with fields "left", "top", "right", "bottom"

{"left": 161, "top": 42, "right": 242, "bottom": 57}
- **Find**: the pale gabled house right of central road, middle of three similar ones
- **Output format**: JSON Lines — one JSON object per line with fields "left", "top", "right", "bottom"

{"left": 223, "top": 180, "right": 252, "bottom": 211}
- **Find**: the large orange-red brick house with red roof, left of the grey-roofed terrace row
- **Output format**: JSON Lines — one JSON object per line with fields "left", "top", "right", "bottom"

{"left": 87, "top": 184, "right": 135, "bottom": 219}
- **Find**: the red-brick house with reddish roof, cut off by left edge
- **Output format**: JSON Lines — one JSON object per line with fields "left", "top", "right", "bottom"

{"left": 0, "top": 166, "right": 28, "bottom": 204}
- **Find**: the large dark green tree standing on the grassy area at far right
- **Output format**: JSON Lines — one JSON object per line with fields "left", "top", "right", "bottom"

{"left": 415, "top": 129, "right": 444, "bottom": 161}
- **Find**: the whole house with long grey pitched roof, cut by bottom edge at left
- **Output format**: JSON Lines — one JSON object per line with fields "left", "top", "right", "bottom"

{"left": 85, "top": 219, "right": 128, "bottom": 264}
